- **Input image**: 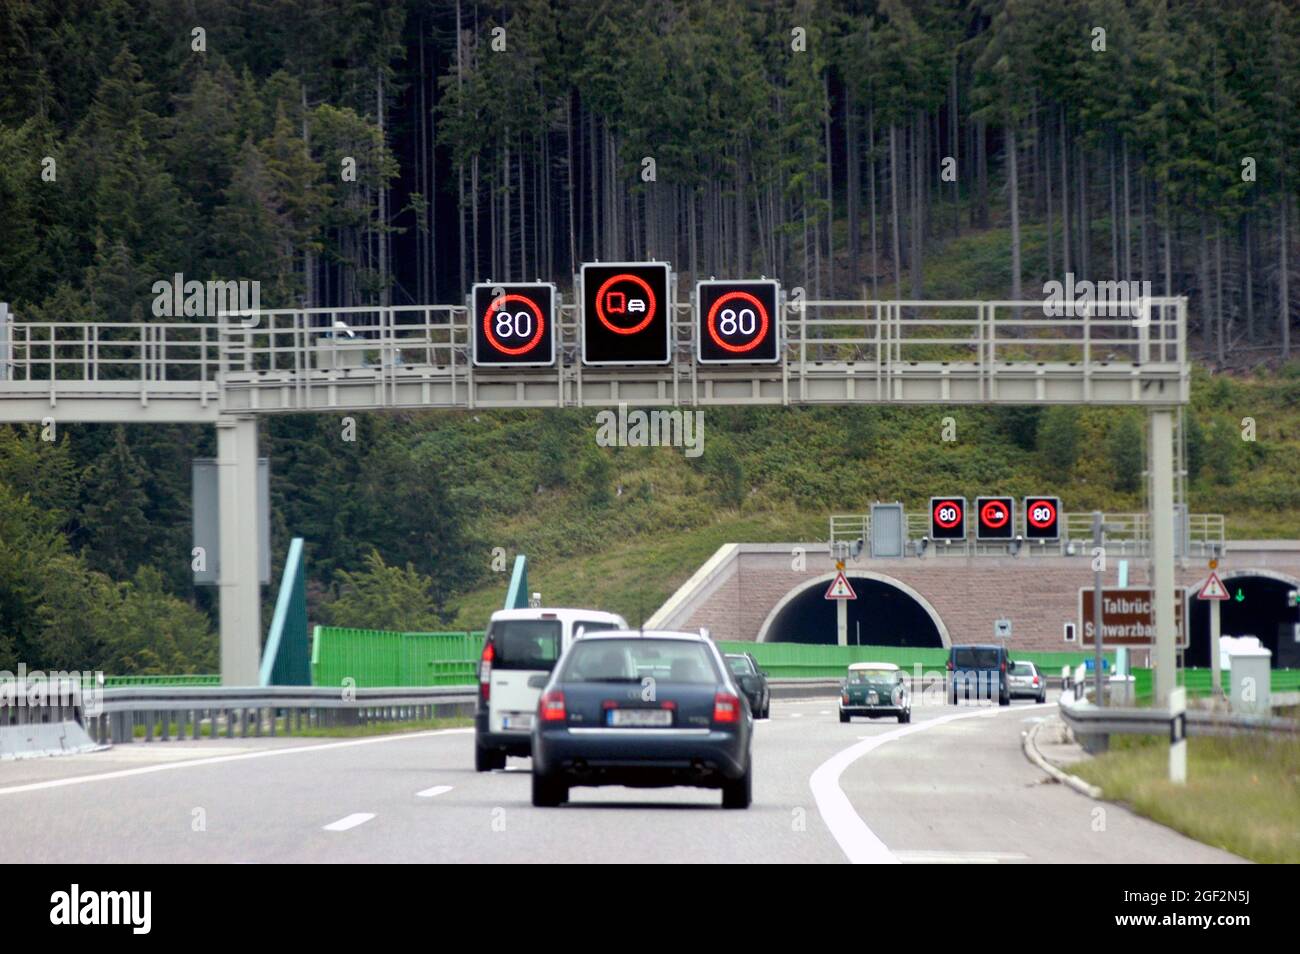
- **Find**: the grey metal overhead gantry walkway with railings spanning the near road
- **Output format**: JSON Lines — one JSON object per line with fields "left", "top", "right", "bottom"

{"left": 0, "top": 298, "right": 1188, "bottom": 420}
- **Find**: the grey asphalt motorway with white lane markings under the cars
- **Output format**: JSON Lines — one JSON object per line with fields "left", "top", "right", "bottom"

{"left": 0, "top": 699, "right": 1239, "bottom": 863}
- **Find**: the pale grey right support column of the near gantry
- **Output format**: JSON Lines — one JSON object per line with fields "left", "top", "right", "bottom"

{"left": 1149, "top": 408, "right": 1178, "bottom": 707}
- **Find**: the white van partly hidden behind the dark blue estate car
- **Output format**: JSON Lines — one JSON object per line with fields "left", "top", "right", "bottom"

{"left": 475, "top": 608, "right": 628, "bottom": 772}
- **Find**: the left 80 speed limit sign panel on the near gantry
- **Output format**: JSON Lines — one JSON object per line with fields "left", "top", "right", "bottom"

{"left": 469, "top": 283, "right": 558, "bottom": 368}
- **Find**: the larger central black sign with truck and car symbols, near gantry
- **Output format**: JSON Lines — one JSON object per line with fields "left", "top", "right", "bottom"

{"left": 580, "top": 261, "right": 672, "bottom": 364}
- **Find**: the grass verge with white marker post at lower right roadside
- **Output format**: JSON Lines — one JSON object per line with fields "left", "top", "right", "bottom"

{"left": 1071, "top": 736, "right": 1300, "bottom": 864}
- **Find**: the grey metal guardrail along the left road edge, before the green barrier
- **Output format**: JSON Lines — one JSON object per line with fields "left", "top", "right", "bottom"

{"left": 78, "top": 686, "right": 475, "bottom": 745}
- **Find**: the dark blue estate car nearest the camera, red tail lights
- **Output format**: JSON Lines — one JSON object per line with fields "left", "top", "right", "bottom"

{"left": 533, "top": 629, "right": 754, "bottom": 808}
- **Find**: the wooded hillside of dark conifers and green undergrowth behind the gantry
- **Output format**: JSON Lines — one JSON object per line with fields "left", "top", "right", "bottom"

{"left": 0, "top": 0, "right": 1300, "bottom": 673}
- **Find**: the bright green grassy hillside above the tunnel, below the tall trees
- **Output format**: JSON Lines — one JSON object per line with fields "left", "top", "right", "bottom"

{"left": 439, "top": 367, "right": 1300, "bottom": 628}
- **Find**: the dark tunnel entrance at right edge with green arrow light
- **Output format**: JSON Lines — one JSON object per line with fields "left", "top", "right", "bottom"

{"left": 1184, "top": 573, "right": 1300, "bottom": 669}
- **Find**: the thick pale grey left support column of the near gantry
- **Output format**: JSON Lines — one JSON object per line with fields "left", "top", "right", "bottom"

{"left": 217, "top": 417, "right": 261, "bottom": 686}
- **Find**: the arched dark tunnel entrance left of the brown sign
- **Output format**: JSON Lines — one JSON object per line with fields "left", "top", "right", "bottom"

{"left": 758, "top": 572, "right": 946, "bottom": 647}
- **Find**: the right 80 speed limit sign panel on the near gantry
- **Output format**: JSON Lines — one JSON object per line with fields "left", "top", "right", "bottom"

{"left": 696, "top": 279, "right": 781, "bottom": 364}
